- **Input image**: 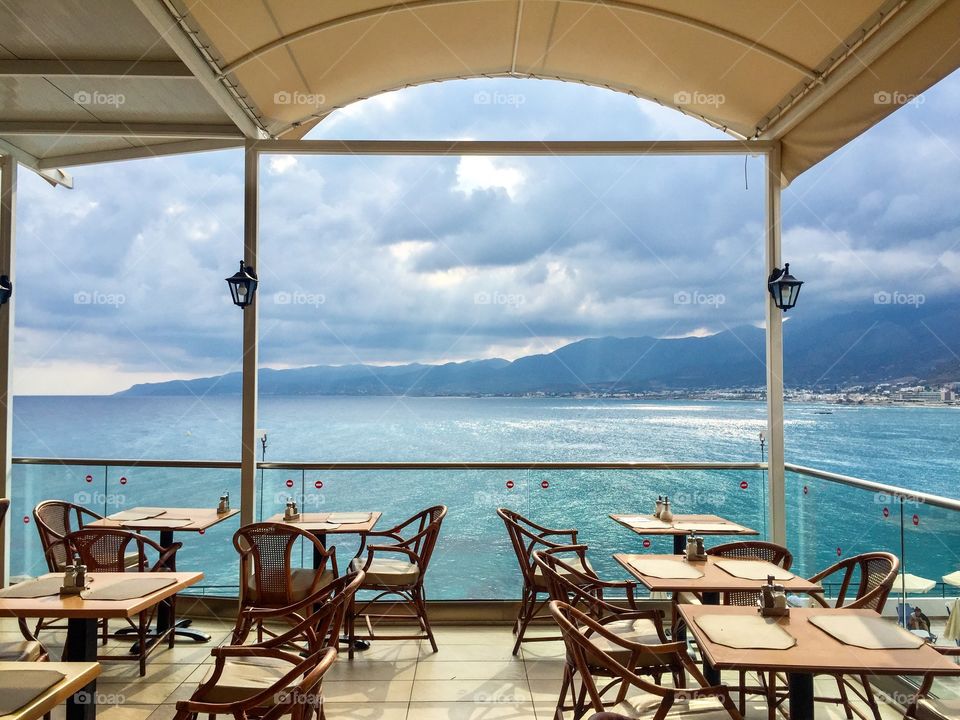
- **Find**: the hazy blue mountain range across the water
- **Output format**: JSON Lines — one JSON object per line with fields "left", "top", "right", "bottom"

{"left": 118, "top": 303, "right": 960, "bottom": 396}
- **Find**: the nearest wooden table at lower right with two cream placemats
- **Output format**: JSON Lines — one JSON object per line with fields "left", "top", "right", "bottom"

{"left": 680, "top": 605, "right": 960, "bottom": 720}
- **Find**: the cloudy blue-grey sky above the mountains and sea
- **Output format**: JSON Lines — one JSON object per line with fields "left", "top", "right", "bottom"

{"left": 14, "top": 73, "right": 960, "bottom": 394}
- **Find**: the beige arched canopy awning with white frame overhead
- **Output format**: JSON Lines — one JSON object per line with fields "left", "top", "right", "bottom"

{"left": 0, "top": 0, "right": 960, "bottom": 186}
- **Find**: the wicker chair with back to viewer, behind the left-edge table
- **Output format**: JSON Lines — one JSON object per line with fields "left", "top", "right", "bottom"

{"left": 63, "top": 527, "right": 183, "bottom": 677}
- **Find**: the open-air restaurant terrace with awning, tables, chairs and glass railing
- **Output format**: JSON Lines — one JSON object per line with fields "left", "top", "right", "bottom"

{"left": 0, "top": 0, "right": 960, "bottom": 720}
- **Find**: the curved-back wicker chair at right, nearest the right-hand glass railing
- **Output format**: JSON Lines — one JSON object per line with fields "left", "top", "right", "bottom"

{"left": 810, "top": 552, "right": 900, "bottom": 720}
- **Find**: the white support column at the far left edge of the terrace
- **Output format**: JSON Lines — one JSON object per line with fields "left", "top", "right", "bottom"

{"left": 0, "top": 155, "right": 17, "bottom": 586}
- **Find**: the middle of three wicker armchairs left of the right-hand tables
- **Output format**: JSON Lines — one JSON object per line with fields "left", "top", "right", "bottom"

{"left": 533, "top": 545, "right": 683, "bottom": 718}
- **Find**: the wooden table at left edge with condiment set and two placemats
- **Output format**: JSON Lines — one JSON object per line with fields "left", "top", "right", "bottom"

{"left": 0, "top": 572, "right": 203, "bottom": 720}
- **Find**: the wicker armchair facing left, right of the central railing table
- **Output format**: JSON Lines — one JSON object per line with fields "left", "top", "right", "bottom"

{"left": 347, "top": 505, "right": 447, "bottom": 659}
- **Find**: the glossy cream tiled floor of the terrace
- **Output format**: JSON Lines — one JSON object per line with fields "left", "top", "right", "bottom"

{"left": 0, "top": 621, "right": 916, "bottom": 720}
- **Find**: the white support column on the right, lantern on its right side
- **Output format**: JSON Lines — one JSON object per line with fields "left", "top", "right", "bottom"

{"left": 763, "top": 143, "right": 787, "bottom": 545}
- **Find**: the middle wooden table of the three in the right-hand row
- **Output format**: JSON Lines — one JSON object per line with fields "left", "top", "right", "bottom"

{"left": 613, "top": 553, "right": 822, "bottom": 684}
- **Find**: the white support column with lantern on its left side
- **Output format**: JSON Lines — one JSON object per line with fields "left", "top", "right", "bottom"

{"left": 240, "top": 143, "right": 260, "bottom": 525}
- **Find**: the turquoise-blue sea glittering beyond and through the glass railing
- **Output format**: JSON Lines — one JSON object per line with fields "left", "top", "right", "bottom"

{"left": 10, "top": 396, "right": 960, "bottom": 599}
